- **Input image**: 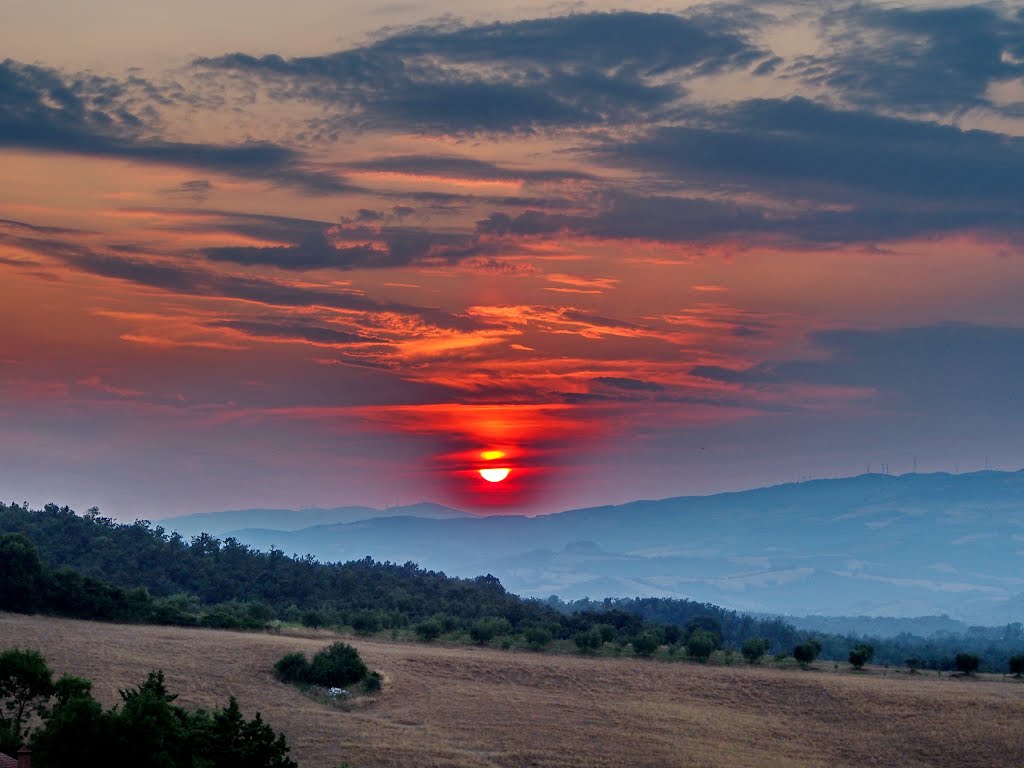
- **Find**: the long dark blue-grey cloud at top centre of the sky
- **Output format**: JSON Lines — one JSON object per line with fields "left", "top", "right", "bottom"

{"left": 196, "top": 12, "right": 763, "bottom": 133}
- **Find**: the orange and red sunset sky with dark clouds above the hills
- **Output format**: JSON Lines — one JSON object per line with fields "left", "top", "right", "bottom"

{"left": 0, "top": 0, "right": 1024, "bottom": 520}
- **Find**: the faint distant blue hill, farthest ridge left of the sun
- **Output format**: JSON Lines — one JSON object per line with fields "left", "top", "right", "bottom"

{"left": 158, "top": 502, "right": 472, "bottom": 539}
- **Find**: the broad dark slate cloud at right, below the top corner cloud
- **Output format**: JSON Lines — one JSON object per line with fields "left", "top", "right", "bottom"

{"left": 593, "top": 98, "right": 1024, "bottom": 241}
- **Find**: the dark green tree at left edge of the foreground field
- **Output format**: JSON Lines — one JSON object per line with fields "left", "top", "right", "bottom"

{"left": 0, "top": 648, "right": 53, "bottom": 755}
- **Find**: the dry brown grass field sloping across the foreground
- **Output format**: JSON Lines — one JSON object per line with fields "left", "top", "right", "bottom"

{"left": 0, "top": 613, "right": 1024, "bottom": 768}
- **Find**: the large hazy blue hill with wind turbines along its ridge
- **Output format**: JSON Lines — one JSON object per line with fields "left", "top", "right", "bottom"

{"left": 199, "top": 471, "right": 1024, "bottom": 624}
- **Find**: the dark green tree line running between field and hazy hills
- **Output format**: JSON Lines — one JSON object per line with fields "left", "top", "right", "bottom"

{"left": 0, "top": 503, "right": 1024, "bottom": 672}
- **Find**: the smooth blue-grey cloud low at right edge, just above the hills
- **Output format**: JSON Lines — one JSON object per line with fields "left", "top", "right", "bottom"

{"left": 690, "top": 324, "right": 1024, "bottom": 418}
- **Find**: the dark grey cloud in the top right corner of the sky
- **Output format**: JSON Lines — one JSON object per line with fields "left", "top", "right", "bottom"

{"left": 792, "top": 3, "right": 1024, "bottom": 113}
